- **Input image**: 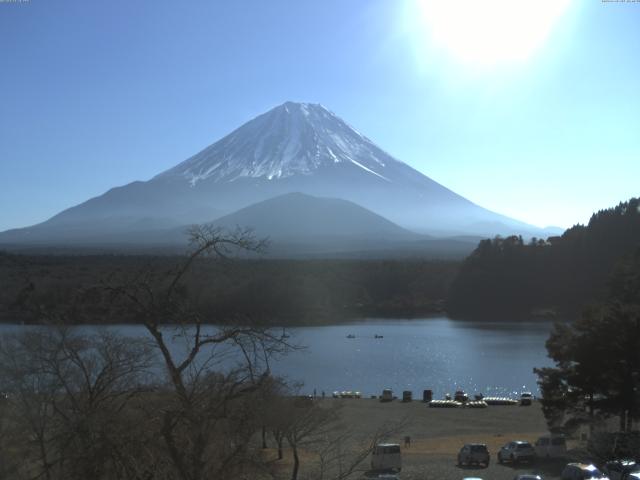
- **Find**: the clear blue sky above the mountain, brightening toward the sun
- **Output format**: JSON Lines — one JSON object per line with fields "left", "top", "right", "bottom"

{"left": 0, "top": 0, "right": 640, "bottom": 230}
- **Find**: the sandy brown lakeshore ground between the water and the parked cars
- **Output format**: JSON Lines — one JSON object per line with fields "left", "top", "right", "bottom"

{"left": 270, "top": 399, "right": 566, "bottom": 480}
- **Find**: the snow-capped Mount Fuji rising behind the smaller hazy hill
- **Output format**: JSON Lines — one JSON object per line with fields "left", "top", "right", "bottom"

{"left": 0, "top": 102, "right": 545, "bottom": 251}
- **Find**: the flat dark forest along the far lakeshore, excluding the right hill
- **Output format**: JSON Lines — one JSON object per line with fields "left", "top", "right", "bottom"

{"left": 0, "top": 254, "right": 460, "bottom": 325}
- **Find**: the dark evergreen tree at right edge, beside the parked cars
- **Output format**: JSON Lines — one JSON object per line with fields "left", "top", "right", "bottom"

{"left": 535, "top": 249, "right": 640, "bottom": 431}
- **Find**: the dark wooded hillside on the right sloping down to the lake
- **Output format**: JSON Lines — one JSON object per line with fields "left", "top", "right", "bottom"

{"left": 447, "top": 198, "right": 640, "bottom": 318}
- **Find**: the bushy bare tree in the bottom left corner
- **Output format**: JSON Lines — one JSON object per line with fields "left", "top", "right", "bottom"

{"left": 0, "top": 328, "right": 152, "bottom": 480}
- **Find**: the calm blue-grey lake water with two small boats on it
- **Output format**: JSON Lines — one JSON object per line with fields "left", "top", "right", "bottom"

{"left": 0, "top": 317, "right": 552, "bottom": 399}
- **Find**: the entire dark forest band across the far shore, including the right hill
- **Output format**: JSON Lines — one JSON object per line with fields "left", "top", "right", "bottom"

{"left": 0, "top": 199, "right": 640, "bottom": 325}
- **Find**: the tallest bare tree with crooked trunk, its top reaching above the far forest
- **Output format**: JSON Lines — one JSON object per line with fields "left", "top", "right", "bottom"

{"left": 109, "top": 226, "right": 290, "bottom": 480}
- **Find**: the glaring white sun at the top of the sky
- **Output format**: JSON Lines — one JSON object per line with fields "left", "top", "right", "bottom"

{"left": 413, "top": 0, "right": 571, "bottom": 66}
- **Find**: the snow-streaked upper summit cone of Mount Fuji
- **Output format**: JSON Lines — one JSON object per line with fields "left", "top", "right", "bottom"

{"left": 156, "top": 102, "right": 397, "bottom": 185}
